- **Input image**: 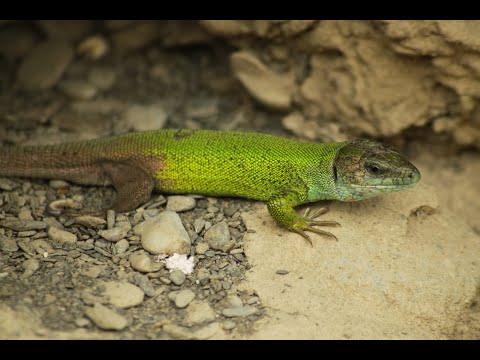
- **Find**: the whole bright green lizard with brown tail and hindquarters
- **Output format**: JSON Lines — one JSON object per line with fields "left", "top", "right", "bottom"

{"left": 0, "top": 129, "right": 420, "bottom": 242}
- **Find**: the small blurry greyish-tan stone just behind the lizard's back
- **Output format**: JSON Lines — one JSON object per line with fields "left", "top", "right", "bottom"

{"left": 124, "top": 105, "right": 168, "bottom": 131}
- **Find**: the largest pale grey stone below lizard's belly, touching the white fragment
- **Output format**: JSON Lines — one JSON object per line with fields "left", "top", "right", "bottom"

{"left": 141, "top": 211, "right": 191, "bottom": 255}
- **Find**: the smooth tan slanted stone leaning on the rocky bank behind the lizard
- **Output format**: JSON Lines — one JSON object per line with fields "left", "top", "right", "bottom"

{"left": 230, "top": 51, "right": 294, "bottom": 110}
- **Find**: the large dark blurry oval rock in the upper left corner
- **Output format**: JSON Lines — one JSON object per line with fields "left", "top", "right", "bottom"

{"left": 17, "top": 40, "right": 73, "bottom": 91}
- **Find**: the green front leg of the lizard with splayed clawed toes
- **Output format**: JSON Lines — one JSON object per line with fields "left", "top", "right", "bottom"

{"left": 267, "top": 191, "right": 340, "bottom": 246}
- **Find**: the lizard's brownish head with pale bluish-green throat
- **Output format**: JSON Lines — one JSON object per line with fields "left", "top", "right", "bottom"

{"left": 333, "top": 139, "right": 420, "bottom": 201}
